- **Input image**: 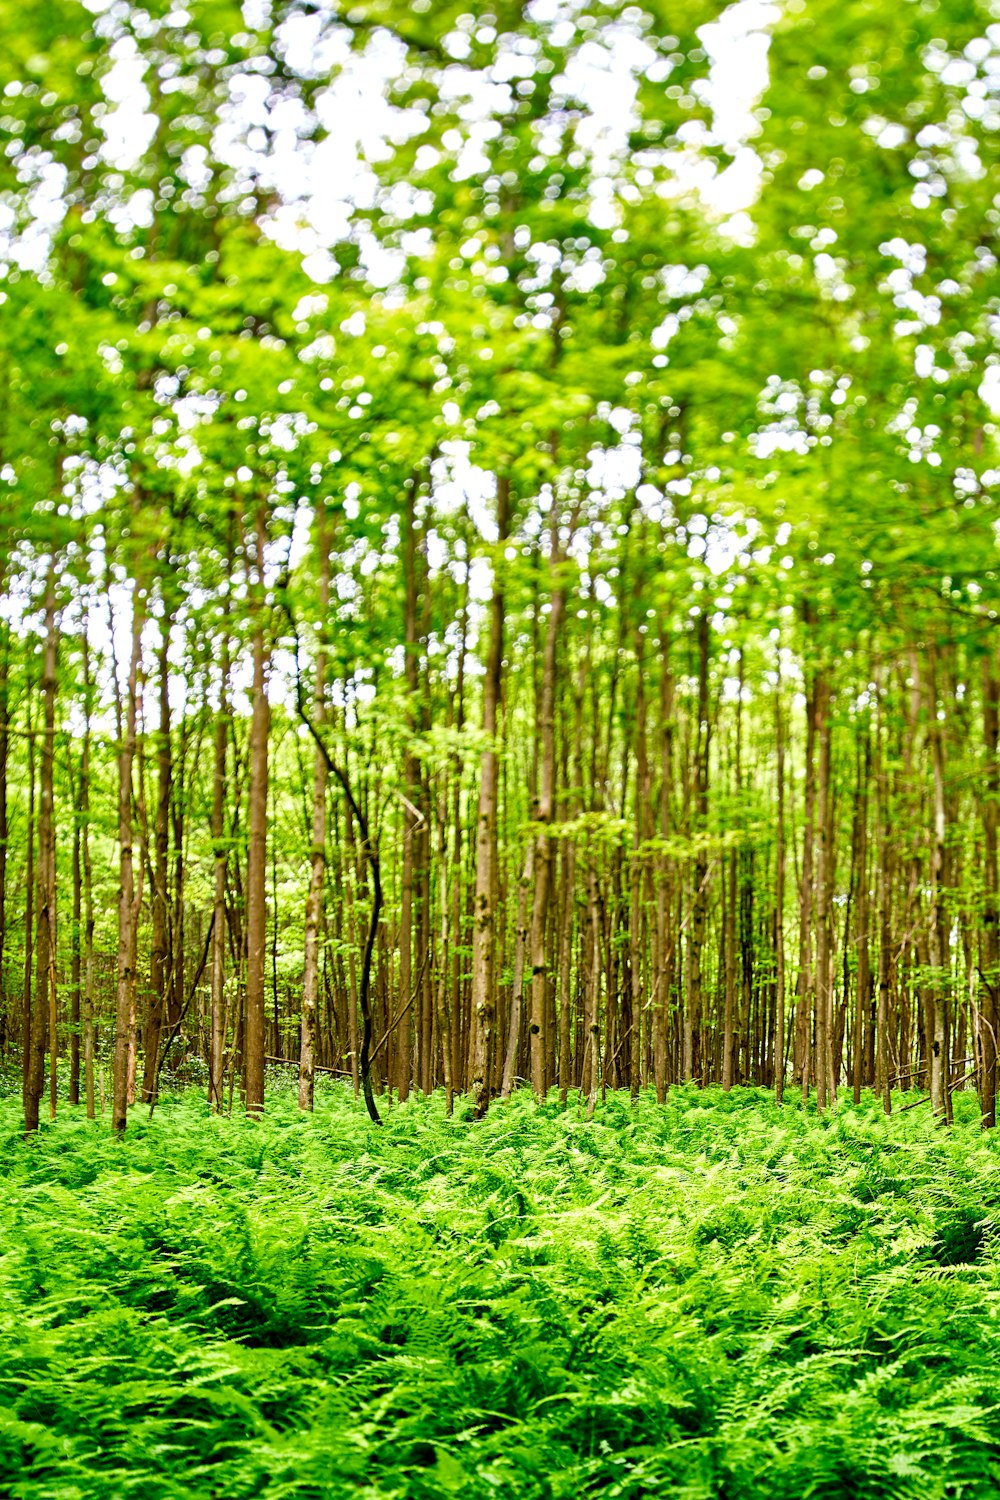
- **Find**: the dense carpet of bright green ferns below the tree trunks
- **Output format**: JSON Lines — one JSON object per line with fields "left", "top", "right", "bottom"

{"left": 0, "top": 1085, "right": 1000, "bottom": 1500}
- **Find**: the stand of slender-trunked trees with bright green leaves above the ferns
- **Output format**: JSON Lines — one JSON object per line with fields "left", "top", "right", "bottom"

{"left": 0, "top": 0, "right": 1000, "bottom": 1133}
